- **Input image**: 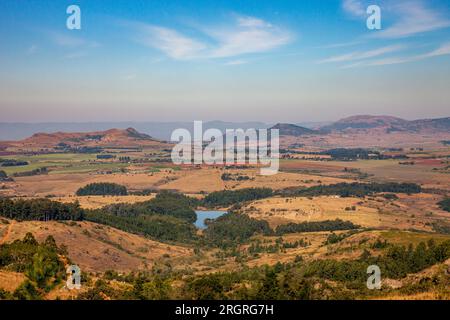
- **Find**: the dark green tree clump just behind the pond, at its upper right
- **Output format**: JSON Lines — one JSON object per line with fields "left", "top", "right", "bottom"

{"left": 204, "top": 188, "right": 273, "bottom": 207}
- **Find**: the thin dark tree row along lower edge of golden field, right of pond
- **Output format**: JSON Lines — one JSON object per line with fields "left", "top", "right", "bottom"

{"left": 275, "top": 219, "right": 359, "bottom": 235}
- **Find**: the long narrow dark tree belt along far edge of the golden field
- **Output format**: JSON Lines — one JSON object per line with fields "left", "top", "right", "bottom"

{"left": 280, "top": 182, "right": 422, "bottom": 197}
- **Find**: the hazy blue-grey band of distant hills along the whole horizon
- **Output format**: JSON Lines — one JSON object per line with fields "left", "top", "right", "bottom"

{"left": 0, "top": 115, "right": 450, "bottom": 142}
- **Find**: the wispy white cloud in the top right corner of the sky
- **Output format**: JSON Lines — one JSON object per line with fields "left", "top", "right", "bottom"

{"left": 375, "top": 0, "right": 450, "bottom": 38}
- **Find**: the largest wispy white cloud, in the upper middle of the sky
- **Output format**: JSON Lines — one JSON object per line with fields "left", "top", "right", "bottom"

{"left": 133, "top": 16, "right": 292, "bottom": 60}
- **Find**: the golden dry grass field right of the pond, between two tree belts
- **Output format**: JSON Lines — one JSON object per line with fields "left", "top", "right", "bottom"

{"left": 243, "top": 194, "right": 450, "bottom": 231}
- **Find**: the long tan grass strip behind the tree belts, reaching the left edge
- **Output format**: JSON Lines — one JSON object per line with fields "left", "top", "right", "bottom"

{"left": 2, "top": 167, "right": 354, "bottom": 197}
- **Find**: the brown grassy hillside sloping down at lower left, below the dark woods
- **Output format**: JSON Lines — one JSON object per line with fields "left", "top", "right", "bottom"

{"left": 0, "top": 221, "right": 192, "bottom": 272}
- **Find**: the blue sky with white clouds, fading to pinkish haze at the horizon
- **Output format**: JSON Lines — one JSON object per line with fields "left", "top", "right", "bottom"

{"left": 0, "top": 0, "right": 450, "bottom": 122}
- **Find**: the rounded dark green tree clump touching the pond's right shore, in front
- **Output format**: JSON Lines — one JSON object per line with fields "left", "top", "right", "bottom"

{"left": 204, "top": 213, "right": 272, "bottom": 247}
